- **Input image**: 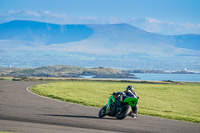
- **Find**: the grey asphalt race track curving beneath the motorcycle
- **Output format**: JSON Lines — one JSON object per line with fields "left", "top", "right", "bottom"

{"left": 0, "top": 81, "right": 200, "bottom": 133}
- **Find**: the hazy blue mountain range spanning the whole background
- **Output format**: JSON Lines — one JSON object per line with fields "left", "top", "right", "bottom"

{"left": 0, "top": 20, "right": 200, "bottom": 71}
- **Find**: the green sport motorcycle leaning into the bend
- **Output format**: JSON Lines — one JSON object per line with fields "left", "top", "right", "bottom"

{"left": 98, "top": 92, "right": 139, "bottom": 119}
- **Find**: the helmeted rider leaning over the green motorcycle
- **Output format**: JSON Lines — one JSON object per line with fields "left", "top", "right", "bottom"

{"left": 106, "top": 85, "right": 139, "bottom": 118}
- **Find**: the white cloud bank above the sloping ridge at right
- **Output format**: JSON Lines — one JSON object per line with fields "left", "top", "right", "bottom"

{"left": 127, "top": 17, "right": 200, "bottom": 35}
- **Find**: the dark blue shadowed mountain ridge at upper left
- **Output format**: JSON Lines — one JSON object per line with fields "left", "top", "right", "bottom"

{"left": 0, "top": 20, "right": 93, "bottom": 45}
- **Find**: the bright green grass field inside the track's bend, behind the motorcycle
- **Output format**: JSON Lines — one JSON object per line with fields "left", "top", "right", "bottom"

{"left": 31, "top": 81, "right": 200, "bottom": 123}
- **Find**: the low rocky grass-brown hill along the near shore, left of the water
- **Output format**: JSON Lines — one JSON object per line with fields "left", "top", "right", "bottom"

{"left": 0, "top": 65, "right": 137, "bottom": 78}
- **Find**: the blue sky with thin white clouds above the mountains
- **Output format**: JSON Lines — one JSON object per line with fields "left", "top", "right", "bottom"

{"left": 0, "top": 0, "right": 200, "bottom": 35}
